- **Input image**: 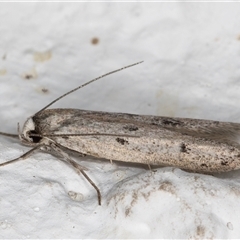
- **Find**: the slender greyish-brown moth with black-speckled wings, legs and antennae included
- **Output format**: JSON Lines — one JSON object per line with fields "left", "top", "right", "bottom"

{"left": 0, "top": 62, "right": 240, "bottom": 205}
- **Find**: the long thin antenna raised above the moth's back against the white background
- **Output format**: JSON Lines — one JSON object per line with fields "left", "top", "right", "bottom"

{"left": 35, "top": 61, "right": 143, "bottom": 115}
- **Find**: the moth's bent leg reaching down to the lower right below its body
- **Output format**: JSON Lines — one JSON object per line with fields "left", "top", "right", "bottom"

{"left": 50, "top": 143, "right": 102, "bottom": 205}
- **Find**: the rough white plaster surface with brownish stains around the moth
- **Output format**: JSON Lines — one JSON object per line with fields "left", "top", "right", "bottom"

{"left": 0, "top": 3, "right": 240, "bottom": 239}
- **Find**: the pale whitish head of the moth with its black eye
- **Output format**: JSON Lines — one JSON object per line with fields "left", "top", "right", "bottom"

{"left": 19, "top": 117, "right": 42, "bottom": 145}
